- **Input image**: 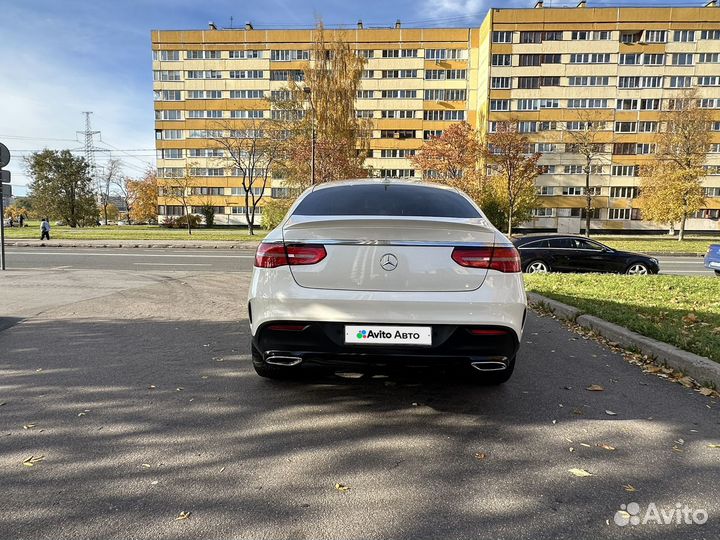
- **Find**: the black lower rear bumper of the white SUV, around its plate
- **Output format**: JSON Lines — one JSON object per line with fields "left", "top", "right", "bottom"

{"left": 252, "top": 321, "right": 519, "bottom": 371}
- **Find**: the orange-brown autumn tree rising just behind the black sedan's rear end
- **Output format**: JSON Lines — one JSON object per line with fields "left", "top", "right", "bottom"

{"left": 483, "top": 120, "right": 541, "bottom": 234}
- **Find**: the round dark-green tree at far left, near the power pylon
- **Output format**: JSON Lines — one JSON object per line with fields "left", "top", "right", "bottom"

{"left": 26, "top": 149, "right": 98, "bottom": 227}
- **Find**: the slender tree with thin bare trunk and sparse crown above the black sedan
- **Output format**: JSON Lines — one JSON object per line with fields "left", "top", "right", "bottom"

{"left": 565, "top": 110, "right": 605, "bottom": 238}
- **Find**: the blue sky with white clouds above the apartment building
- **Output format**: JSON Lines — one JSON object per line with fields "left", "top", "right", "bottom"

{"left": 0, "top": 0, "right": 703, "bottom": 195}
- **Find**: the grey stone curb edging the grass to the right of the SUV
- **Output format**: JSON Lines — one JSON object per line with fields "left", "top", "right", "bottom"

{"left": 527, "top": 293, "right": 720, "bottom": 388}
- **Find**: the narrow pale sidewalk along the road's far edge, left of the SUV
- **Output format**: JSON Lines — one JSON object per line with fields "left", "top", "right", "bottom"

{"left": 5, "top": 239, "right": 260, "bottom": 250}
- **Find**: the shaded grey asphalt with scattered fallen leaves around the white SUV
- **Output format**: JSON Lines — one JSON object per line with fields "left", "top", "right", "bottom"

{"left": 0, "top": 267, "right": 720, "bottom": 540}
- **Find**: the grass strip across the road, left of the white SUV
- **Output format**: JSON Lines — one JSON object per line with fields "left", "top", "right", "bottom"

{"left": 5, "top": 221, "right": 267, "bottom": 242}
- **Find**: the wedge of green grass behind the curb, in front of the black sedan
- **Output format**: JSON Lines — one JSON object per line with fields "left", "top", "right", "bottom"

{"left": 525, "top": 274, "right": 720, "bottom": 362}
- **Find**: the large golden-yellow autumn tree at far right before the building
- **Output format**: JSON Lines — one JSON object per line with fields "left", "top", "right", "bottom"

{"left": 640, "top": 89, "right": 711, "bottom": 241}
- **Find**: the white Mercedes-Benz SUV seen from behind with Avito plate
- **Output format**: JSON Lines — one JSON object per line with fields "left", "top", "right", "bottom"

{"left": 248, "top": 180, "right": 527, "bottom": 384}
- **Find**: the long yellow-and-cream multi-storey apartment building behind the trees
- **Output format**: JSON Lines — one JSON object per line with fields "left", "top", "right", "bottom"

{"left": 152, "top": 2, "right": 720, "bottom": 232}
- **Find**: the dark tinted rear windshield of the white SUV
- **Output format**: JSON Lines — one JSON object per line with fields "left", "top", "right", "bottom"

{"left": 293, "top": 183, "right": 480, "bottom": 218}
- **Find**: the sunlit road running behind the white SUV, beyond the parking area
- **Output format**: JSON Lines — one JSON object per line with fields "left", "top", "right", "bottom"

{"left": 0, "top": 247, "right": 714, "bottom": 276}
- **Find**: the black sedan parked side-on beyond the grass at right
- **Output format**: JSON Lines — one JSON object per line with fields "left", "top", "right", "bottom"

{"left": 513, "top": 234, "right": 660, "bottom": 275}
